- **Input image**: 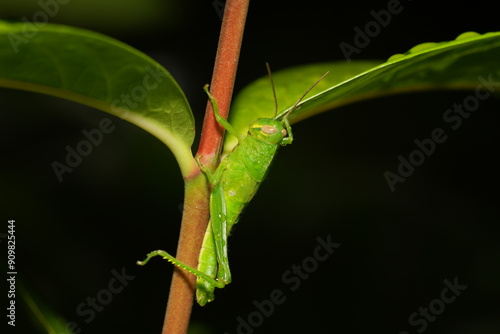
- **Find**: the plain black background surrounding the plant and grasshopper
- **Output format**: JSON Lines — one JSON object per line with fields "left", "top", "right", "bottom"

{"left": 0, "top": 0, "right": 500, "bottom": 334}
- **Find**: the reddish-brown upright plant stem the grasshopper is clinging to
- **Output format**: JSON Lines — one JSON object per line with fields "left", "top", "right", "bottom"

{"left": 162, "top": 0, "right": 250, "bottom": 334}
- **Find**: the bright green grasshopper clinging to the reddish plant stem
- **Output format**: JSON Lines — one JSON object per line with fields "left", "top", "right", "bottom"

{"left": 137, "top": 64, "right": 328, "bottom": 306}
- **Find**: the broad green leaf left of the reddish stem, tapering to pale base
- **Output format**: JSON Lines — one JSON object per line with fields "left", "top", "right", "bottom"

{"left": 0, "top": 22, "right": 196, "bottom": 176}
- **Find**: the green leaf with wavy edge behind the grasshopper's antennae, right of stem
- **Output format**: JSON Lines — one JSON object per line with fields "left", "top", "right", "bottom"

{"left": 224, "top": 32, "right": 500, "bottom": 153}
